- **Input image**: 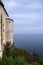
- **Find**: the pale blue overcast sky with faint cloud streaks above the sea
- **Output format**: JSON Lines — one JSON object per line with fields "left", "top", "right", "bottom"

{"left": 3, "top": 0, "right": 43, "bottom": 33}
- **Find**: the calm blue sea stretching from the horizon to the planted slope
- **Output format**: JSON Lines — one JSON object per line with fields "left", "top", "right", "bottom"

{"left": 14, "top": 34, "right": 43, "bottom": 56}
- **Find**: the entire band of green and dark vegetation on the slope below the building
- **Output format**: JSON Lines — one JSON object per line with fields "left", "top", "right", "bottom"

{"left": 0, "top": 43, "right": 43, "bottom": 65}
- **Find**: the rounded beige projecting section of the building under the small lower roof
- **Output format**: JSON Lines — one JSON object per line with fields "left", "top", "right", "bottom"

{"left": 6, "top": 18, "right": 13, "bottom": 43}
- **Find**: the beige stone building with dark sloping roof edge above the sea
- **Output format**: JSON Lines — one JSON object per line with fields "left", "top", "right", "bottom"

{"left": 0, "top": 0, "right": 13, "bottom": 57}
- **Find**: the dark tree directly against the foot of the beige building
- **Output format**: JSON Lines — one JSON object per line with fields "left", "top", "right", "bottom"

{"left": 3, "top": 42, "right": 14, "bottom": 57}
